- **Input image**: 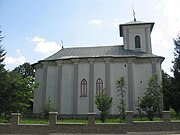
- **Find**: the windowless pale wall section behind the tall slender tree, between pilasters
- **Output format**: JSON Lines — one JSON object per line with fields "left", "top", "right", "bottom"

{"left": 110, "top": 63, "right": 128, "bottom": 114}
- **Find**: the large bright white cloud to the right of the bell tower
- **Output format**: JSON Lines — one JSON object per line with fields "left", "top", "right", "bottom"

{"left": 152, "top": 0, "right": 180, "bottom": 75}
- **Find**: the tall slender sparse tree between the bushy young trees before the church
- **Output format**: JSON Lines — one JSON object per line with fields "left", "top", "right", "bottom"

{"left": 116, "top": 76, "right": 126, "bottom": 120}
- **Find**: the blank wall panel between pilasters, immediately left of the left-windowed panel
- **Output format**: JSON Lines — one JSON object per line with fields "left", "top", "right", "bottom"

{"left": 61, "top": 64, "right": 73, "bottom": 114}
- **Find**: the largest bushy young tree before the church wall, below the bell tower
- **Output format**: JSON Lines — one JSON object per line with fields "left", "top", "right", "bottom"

{"left": 140, "top": 75, "right": 162, "bottom": 120}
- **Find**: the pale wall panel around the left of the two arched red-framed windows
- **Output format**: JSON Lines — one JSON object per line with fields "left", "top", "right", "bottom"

{"left": 78, "top": 63, "right": 89, "bottom": 114}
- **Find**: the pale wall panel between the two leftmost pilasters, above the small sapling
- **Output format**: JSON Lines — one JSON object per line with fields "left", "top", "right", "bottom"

{"left": 46, "top": 65, "right": 57, "bottom": 107}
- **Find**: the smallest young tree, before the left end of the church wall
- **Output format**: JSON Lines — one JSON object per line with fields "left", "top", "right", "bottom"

{"left": 42, "top": 97, "right": 55, "bottom": 119}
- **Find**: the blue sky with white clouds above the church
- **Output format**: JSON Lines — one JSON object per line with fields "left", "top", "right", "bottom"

{"left": 0, "top": 0, "right": 180, "bottom": 76}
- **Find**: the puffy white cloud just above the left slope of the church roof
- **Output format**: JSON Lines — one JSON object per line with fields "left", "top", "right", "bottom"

{"left": 31, "top": 36, "right": 61, "bottom": 55}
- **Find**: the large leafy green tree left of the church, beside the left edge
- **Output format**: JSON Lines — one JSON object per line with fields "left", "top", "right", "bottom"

{"left": 1, "top": 71, "right": 37, "bottom": 116}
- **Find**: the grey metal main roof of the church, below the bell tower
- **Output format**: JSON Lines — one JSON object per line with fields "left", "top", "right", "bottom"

{"left": 42, "top": 45, "right": 164, "bottom": 61}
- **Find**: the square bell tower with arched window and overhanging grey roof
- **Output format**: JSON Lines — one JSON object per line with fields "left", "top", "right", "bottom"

{"left": 119, "top": 19, "right": 154, "bottom": 54}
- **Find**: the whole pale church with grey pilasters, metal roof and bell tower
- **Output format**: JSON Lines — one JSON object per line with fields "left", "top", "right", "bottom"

{"left": 33, "top": 20, "right": 164, "bottom": 115}
